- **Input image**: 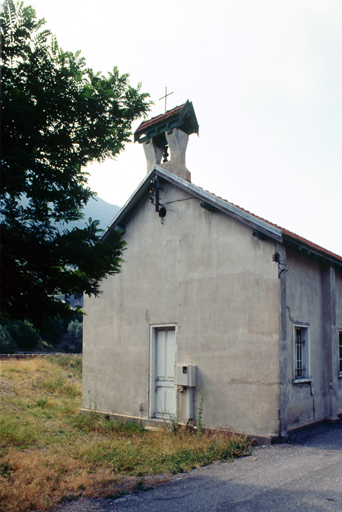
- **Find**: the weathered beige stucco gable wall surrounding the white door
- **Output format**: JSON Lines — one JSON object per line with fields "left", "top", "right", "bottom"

{"left": 83, "top": 184, "right": 279, "bottom": 435}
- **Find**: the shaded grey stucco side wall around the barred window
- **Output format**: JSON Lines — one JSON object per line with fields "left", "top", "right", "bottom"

{"left": 281, "top": 247, "right": 342, "bottom": 432}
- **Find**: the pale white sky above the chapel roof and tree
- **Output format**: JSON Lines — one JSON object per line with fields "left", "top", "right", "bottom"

{"left": 30, "top": 0, "right": 342, "bottom": 255}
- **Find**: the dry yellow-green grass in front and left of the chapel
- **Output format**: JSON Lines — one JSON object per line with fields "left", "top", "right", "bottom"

{"left": 0, "top": 356, "right": 251, "bottom": 512}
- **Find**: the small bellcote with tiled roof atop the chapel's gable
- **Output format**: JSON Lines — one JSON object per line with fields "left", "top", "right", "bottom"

{"left": 134, "top": 100, "right": 199, "bottom": 181}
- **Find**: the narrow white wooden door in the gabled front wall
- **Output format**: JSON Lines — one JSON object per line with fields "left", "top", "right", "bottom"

{"left": 154, "top": 328, "right": 176, "bottom": 418}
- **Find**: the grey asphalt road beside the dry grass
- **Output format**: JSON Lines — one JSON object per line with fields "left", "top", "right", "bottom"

{"left": 55, "top": 422, "right": 342, "bottom": 512}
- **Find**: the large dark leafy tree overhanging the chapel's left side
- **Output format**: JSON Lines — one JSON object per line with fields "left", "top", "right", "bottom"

{"left": 0, "top": 0, "right": 150, "bottom": 330}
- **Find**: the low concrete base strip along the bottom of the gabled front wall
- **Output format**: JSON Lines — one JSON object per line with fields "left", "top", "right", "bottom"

{"left": 80, "top": 409, "right": 279, "bottom": 446}
